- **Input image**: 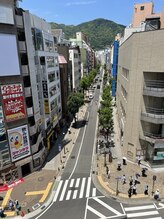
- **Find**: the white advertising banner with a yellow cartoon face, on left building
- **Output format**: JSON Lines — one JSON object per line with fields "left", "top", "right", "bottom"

{"left": 7, "top": 125, "right": 31, "bottom": 162}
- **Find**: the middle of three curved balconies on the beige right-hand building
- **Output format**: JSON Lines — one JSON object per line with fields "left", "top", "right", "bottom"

{"left": 141, "top": 107, "right": 164, "bottom": 124}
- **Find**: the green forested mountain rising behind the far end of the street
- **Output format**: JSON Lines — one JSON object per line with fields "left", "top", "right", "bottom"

{"left": 50, "top": 18, "right": 125, "bottom": 50}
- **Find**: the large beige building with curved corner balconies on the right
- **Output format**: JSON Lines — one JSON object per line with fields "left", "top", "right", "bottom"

{"left": 116, "top": 2, "right": 164, "bottom": 166}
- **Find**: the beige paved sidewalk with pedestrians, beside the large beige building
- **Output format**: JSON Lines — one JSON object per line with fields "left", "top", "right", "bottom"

{"left": 95, "top": 104, "right": 164, "bottom": 202}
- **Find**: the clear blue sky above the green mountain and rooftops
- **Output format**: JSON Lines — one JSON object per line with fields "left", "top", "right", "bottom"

{"left": 19, "top": 0, "right": 164, "bottom": 25}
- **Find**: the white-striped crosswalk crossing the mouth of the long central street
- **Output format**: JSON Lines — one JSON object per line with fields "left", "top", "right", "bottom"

{"left": 53, "top": 177, "right": 97, "bottom": 202}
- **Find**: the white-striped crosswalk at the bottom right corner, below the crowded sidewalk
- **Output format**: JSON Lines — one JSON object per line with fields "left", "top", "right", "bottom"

{"left": 124, "top": 204, "right": 162, "bottom": 219}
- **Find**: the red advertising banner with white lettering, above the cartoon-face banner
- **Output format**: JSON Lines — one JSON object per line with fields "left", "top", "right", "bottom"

{"left": 1, "top": 84, "right": 26, "bottom": 122}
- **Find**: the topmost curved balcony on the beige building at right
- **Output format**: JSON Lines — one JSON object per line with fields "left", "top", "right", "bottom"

{"left": 143, "top": 80, "right": 164, "bottom": 97}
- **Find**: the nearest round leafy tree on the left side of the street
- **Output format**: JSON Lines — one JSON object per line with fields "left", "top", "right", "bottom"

{"left": 67, "top": 92, "right": 84, "bottom": 123}
